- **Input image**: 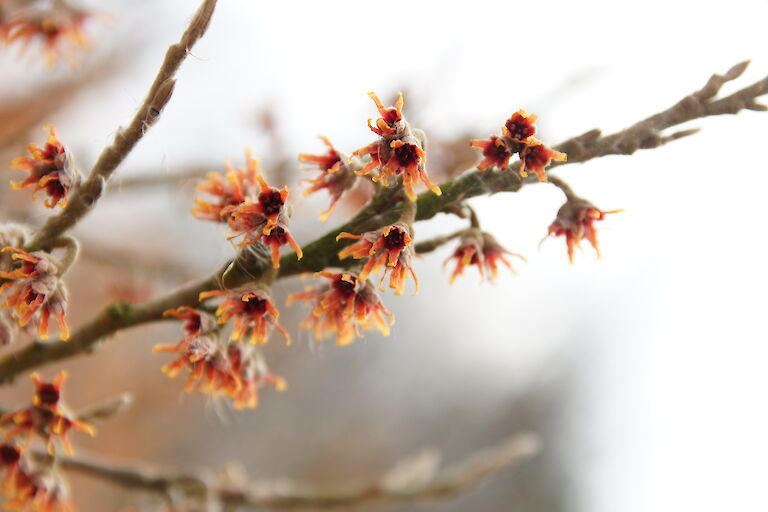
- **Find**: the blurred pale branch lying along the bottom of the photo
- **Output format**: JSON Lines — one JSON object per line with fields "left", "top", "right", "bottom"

{"left": 37, "top": 433, "right": 540, "bottom": 509}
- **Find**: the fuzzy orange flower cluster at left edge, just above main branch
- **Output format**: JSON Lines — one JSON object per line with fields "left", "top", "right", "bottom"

{"left": 0, "top": 246, "right": 69, "bottom": 341}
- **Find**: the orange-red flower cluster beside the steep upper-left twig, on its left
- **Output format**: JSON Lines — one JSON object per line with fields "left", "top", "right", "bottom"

{"left": 11, "top": 126, "right": 76, "bottom": 208}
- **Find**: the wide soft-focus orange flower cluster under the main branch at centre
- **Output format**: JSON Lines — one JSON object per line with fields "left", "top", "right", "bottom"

{"left": 288, "top": 271, "right": 395, "bottom": 345}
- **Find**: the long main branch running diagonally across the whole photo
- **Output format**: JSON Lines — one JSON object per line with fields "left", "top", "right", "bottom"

{"left": 0, "top": 63, "right": 768, "bottom": 382}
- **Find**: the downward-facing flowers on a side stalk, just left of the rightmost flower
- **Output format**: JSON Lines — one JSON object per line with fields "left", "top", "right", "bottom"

{"left": 444, "top": 228, "right": 525, "bottom": 284}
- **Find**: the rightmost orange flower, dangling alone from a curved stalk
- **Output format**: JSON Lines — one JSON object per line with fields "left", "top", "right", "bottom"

{"left": 545, "top": 198, "right": 621, "bottom": 263}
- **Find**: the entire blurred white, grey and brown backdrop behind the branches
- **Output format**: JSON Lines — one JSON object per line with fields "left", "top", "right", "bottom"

{"left": 0, "top": 0, "right": 768, "bottom": 512}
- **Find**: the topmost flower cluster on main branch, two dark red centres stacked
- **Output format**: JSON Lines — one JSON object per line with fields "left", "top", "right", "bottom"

{"left": 352, "top": 92, "right": 442, "bottom": 201}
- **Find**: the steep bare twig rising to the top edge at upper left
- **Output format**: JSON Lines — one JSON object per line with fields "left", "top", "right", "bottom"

{"left": 26, "top": 0, "right": 216, "bottom": 250}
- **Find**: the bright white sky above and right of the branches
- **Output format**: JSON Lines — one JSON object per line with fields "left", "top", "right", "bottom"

{"left": 0, "top": 0, "right": 768, "bottom": 512}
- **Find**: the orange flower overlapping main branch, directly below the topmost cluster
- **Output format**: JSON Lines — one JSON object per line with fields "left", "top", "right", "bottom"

{"left": 336, "top": 223, "right": 419, "bottom": 295}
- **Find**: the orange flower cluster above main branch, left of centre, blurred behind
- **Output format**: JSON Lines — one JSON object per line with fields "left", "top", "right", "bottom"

{"left": 192, "top": 151, "right": 302, "bottom": 268}
